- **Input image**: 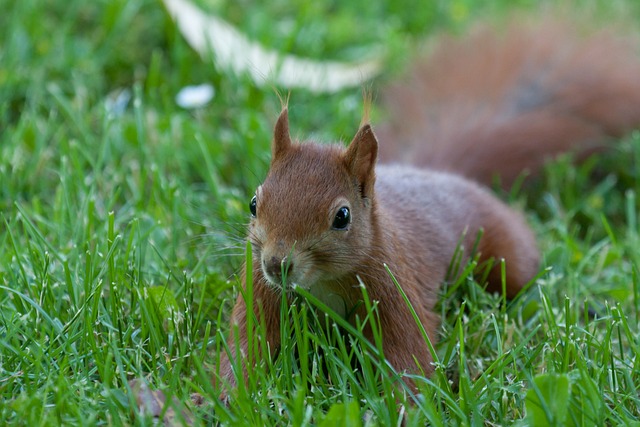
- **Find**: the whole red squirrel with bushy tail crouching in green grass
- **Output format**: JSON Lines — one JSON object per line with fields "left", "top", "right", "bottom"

{"left": 216, "top": 18, "right": 640, "bottom": 396}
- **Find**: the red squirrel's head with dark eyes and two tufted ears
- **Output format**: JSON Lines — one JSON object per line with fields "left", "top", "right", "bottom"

{"left": 249, "top": 109, "right": 378, "bottom": 300}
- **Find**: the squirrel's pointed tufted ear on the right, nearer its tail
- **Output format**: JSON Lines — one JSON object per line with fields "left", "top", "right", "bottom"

{"left": 344, "top": 124, "right": 378, "bottom": 198}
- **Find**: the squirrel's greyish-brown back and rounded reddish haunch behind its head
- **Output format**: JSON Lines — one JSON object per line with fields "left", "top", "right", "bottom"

{"left": 376, "top": 165, "right": 540, "bottom": 298}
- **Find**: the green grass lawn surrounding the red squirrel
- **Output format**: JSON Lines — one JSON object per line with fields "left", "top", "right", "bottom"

{"left": 0, "top": 0, "right": 640, "bottom": 426}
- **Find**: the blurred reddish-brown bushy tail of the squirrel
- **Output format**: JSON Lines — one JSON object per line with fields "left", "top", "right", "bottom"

{"left": 378, "top": 16, "right": 640, "bottom": 185}
